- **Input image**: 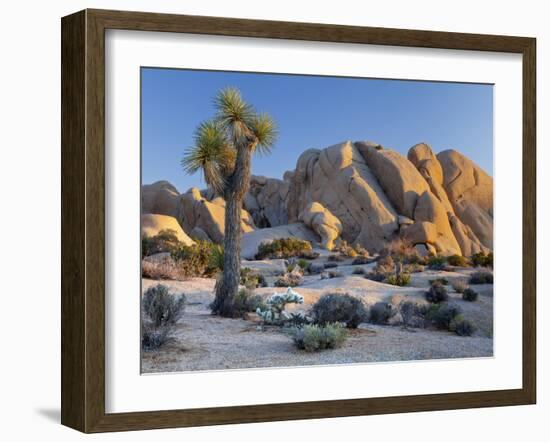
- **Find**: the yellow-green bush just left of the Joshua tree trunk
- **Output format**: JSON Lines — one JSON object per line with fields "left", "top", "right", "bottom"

{"left": 171, "top": 241, "right": 224, "bottom": 276}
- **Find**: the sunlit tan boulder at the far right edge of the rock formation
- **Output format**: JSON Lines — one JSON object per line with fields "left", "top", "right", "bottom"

{"left": 437, "top": 150, "right": 493, "bottom": 249}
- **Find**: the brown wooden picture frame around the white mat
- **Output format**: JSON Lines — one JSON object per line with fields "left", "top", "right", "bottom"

{"left": 61, "top": 6, "right": 536, "bottom": 432}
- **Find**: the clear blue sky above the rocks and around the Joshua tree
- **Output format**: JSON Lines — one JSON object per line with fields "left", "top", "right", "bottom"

{"left": 141, "top": 68, "right": 493, "bottom": 192}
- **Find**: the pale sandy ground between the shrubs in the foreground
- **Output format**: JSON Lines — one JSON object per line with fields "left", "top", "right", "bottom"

{"left": 142, "top": 264, "right": 493, "bottom": 373}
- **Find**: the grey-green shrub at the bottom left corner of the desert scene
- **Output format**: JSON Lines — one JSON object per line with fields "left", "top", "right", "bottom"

{"left": 141, "top": 284, "right": 185, "bottom": 327}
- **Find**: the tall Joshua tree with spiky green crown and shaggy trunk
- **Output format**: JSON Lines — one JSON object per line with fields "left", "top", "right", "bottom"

{"left": 182, "top": 88, "right": 277, "bottom": 317}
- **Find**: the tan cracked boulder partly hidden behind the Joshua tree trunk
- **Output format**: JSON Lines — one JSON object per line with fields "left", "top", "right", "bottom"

{"left": 178, "top": 188, "right": 254, "bottom": 243}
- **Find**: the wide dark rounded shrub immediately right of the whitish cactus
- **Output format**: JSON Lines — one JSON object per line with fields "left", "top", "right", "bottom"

{"left": 311, "top": 293, "right": 367, "bottom": 328}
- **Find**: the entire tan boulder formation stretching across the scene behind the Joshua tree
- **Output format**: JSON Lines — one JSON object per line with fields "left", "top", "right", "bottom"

{"left": 142, "top": 141, "right": 493, "bottom": 259}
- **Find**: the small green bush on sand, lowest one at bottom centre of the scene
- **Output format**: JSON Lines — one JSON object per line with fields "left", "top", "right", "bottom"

{"left": 293, "top": 324, "right": 347, "bottom": 351}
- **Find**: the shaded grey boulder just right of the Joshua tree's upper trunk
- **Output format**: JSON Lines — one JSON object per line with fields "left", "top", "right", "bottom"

{"left": 244, "top": 175, "right": 289, "bottom": 228}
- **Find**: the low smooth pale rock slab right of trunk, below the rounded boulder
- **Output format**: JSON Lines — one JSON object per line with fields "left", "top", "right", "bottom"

{"left": 241, "top": 223, "right": 319, "bottom": 259}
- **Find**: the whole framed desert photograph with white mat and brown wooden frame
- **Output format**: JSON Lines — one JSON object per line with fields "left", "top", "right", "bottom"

{"left": 61, "top": 10, "right": 536, "bottom": 432}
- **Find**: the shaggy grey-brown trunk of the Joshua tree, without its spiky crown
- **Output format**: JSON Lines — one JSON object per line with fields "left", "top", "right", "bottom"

{"left": 212, "top": 140, "right": 255, "bottom": 317}
